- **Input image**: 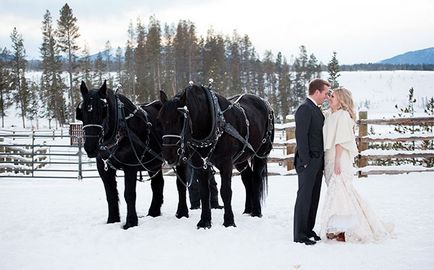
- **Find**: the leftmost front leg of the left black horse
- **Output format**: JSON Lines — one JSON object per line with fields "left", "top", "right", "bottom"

{"left": 96, "top": 158, "right": 121, "bottom": 223}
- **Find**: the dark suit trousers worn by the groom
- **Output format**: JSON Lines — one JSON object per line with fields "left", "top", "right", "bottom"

{"left": 294, "top": 153, "right": 324, "bottom": 241}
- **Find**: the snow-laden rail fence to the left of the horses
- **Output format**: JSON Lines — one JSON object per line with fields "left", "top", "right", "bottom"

{"left": 0, "top": 130, "right": 99, "bottom": 179}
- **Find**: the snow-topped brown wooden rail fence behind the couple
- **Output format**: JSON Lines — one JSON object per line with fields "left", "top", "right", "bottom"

{"left": 269, "top": 112, "right": 434, "bottom": 177}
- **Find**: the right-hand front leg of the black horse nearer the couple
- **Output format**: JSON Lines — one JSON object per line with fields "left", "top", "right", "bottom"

{"left": 220, "top": 163, "right": 236, "bottom": 227}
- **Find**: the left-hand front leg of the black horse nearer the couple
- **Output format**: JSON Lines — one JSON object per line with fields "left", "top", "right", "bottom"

{"left": 195, "top": 169, "right": 211, "bottom": 229}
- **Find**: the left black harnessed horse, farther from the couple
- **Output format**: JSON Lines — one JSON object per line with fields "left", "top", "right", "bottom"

{"left": 76, "top": 82, "right": 188, "bottom": 229}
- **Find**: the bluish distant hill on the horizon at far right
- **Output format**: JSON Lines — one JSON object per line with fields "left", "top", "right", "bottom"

{"left": 380, "top": 47, "right": 434, "bottom": 65}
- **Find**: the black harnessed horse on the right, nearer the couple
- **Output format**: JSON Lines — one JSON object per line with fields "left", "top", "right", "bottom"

{"left": 158, "top": 85, "right": 274, "bottom": 228}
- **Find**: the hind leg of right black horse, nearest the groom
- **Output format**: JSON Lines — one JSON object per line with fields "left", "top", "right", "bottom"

{"left": 251, "top": 157, "right": 267, "bottom": 217}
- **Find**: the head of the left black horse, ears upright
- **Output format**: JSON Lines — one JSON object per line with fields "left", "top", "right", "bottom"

{"left": 76, "top": 81, "right": 108, "bottom": 158}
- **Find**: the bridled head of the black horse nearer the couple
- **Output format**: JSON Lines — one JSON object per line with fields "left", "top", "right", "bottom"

{"left": 158, "top": 91, "right": 188, "bottom": 166}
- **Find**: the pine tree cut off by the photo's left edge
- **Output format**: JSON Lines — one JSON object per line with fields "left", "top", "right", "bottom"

{"left": 0, "top": 48, "right": 12, "bottom": 128}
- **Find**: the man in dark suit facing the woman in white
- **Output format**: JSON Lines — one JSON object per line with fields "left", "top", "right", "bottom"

{"left": 294, "top": 79, "right": 330, "bottom": 245}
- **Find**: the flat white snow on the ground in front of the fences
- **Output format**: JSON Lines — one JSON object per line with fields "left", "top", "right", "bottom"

{"left": 0, "top": 173, "right": 434, "bottom": 270}
